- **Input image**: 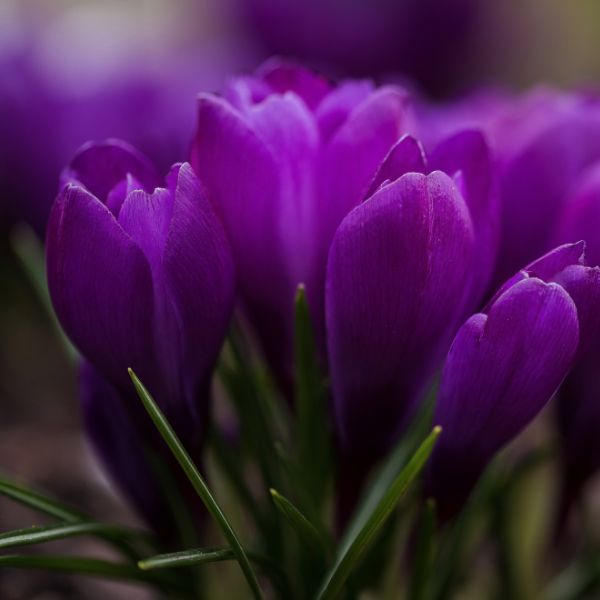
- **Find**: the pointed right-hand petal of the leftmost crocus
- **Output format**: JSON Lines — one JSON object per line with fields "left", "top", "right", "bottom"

{"left": 161, "top": 164, "right": 235, "bottom": 422}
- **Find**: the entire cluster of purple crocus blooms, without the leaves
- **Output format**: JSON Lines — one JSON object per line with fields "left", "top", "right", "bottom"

{"left": 48, "top": 61, "right": 600, "bottom": 536}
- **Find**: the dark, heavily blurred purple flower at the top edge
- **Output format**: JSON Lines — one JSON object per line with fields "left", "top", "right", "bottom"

{"left": 238, "top": 0, "right": 482, "bottom": 92}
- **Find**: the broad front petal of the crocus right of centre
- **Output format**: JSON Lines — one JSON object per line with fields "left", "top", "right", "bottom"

{"left": 326, "top": 173, "right": 473, "bottom": 460}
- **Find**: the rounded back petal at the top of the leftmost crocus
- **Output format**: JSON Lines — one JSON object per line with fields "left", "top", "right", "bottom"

{"left": 61, "top": 140, "right": 159, "bottom": 201}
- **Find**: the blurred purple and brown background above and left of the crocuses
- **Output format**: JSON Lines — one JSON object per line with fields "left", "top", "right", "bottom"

{"left": 0, "top": 0, "right": 600, "bottom": 599}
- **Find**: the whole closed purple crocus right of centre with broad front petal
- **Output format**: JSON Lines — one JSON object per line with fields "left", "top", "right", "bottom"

{"left": 326, "top": 131, "right": 498, "bottom": 467}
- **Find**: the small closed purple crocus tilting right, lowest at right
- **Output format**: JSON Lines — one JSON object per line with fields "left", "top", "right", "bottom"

{"left": 426, "top": 242, "right": 600, "bottom": 518}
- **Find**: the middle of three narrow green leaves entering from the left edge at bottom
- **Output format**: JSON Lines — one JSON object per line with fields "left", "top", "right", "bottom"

{"left": 0, "top": 521, "right": 139, "bottom": 548}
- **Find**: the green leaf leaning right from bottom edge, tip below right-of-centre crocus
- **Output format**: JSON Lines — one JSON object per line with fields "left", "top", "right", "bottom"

{"left": 318, "top": 427, "right": 441, "bottom": 600}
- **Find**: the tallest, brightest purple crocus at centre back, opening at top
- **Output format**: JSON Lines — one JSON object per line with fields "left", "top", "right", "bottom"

{"left": 191, "top": 58, "right": 409, "bottom": 390}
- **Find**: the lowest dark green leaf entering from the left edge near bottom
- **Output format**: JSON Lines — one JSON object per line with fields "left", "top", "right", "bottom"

{"left": 0, "top": 554, "right": 186, "bottom": 592}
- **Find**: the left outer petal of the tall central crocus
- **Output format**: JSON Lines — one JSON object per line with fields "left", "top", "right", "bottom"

{"left": 192, "top": 96, "right": 305, "bottom": 384}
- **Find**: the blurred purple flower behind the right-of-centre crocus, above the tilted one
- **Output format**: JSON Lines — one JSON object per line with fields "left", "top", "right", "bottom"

{"left": 421, "top": 88, "right": 600, "bottom": 285}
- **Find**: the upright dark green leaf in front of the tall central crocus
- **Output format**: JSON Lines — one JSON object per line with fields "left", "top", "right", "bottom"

{"left": 294, "top": 285, "right": 332, "bottom": 515}
